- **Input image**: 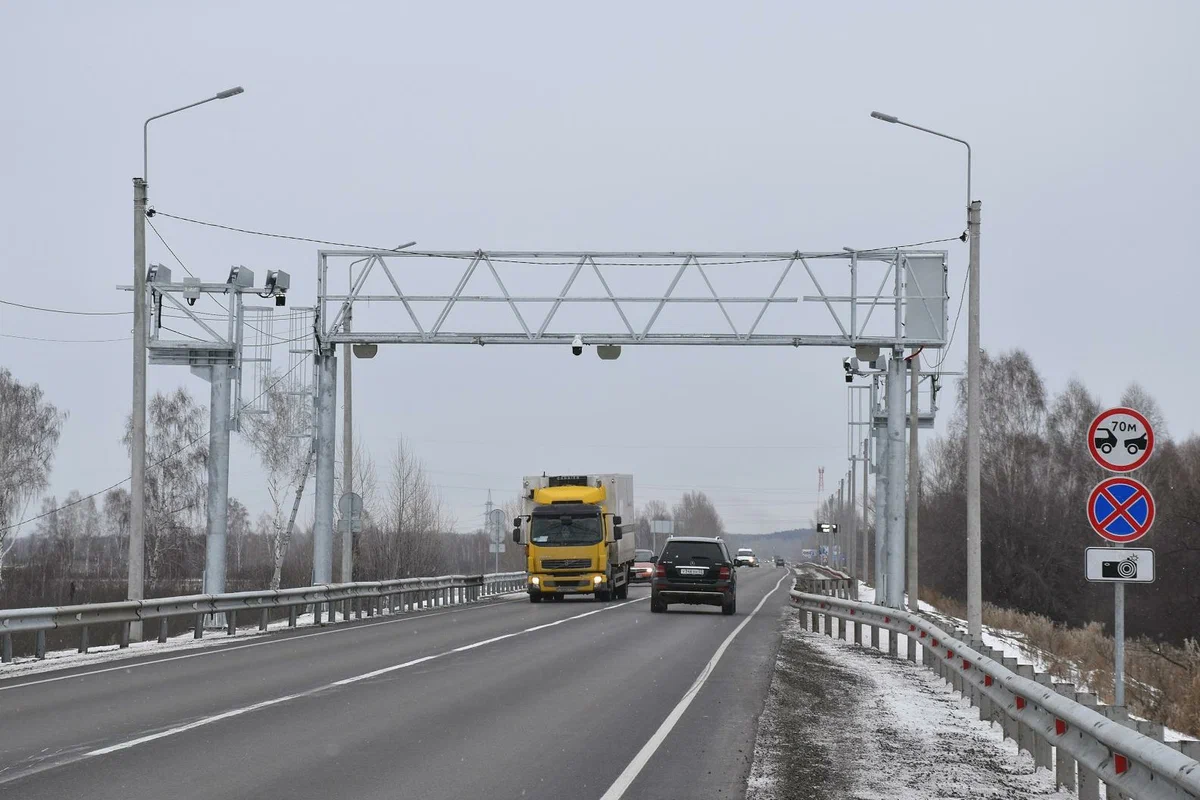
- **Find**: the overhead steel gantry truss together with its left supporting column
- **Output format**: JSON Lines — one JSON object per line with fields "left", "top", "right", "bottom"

{"left": 313, "top": 248, "right": 947, "bottom": 583}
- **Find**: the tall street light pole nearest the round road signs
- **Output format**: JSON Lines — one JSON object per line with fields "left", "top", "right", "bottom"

{"left": 871, "top": 112, "right": 983, "bottom": 642}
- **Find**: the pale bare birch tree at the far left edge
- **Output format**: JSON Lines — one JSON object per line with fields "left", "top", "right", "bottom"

{"left": 0, "top": 368, "right": 67, "bottom": 579}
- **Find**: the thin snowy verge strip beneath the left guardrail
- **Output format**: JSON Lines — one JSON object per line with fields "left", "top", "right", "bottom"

{"left": 0, "top": 591, "right": 528, "bottom": 680}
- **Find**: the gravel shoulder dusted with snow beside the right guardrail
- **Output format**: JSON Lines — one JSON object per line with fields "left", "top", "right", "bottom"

{"left": 746, "top": 612, "right": 1073, "bottom": 800}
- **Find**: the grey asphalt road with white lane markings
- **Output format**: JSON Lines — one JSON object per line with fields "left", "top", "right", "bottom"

{"left": 0, "top": 567, "right": 790, "bottom": 800}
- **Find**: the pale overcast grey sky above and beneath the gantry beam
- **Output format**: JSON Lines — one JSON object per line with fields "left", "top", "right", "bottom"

{"left": 0, "top": 1, "right": 1200, "bottom": 533}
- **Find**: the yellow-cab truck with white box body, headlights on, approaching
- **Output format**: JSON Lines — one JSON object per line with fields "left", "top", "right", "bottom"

{"left": 512, "top": 474, "right": 634, "bottom": 603}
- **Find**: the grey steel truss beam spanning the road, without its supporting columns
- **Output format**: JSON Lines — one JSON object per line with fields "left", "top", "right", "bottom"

{"left": 317, "top": 249, "right": 947, "bottom": 350}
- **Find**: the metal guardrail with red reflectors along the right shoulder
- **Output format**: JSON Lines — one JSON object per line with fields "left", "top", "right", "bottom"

{"left": 791, "top": 576, "right": 1200, "bottom": 800}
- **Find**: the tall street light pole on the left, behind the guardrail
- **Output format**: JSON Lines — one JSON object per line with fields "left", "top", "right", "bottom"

{"left": 128, "top": 86, "right": 244, "bottom": 642}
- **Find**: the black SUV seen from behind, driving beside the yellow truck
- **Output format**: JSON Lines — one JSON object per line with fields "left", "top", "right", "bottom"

{"left": 650, "top": 536, "right": 738, "bottom": 614}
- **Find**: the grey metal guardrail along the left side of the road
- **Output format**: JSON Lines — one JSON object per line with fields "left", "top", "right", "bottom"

{"left": 0, "top": 572, "right": 526, "bottom": 663}
